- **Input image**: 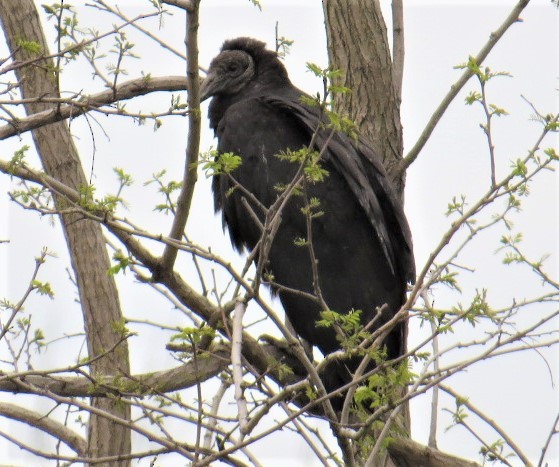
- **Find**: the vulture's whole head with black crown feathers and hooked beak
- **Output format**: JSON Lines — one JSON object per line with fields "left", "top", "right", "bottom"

{"left": 200, "top": 37, "right": 289, "bottom": 101}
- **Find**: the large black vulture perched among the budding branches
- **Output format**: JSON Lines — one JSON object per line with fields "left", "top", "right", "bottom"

{"left": 201, "top": 37, "right": 415, "bottom": 406}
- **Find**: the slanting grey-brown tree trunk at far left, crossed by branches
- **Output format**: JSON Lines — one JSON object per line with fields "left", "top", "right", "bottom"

{"left": 0, "top": 0, "right": 131, "bottom": 467}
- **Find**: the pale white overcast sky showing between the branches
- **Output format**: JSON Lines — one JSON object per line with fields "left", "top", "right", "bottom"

{"left": 0, "top": 0, "right": 559, "bottom": 466}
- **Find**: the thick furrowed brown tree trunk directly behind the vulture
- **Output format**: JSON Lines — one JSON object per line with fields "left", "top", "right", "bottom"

{"left": 323, "top": 0, "right": 411, "bottom": 467}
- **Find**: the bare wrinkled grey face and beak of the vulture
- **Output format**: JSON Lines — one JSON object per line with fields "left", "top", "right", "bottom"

{"left": 200, "top": 50, "right": 256, "bottom": 101}
